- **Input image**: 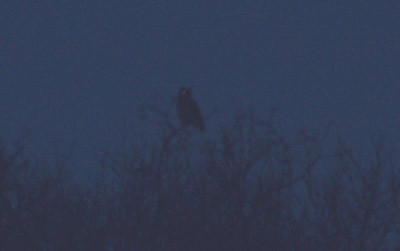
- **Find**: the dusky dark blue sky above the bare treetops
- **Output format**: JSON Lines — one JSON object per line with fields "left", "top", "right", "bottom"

{"left": 0, "top": 0, "right": 400, "bottom": 173}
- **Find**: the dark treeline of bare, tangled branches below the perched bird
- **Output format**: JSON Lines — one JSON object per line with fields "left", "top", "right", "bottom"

{"left": 0, "top": 113, "right": 400, "bottom": 251}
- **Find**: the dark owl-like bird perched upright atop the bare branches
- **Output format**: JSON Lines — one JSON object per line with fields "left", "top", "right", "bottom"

{"left": 176, "top": 87, "right": 204, "bottom": 131}
